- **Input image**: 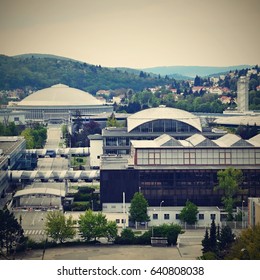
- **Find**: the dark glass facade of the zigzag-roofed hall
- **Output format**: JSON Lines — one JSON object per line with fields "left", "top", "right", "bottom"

{"left": 100, "top": 168, "right": 260, "bottom": 206}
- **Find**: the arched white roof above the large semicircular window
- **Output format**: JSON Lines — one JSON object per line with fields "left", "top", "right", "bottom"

{"left": 127, "top": 107, "right": 202, "bottom": 132}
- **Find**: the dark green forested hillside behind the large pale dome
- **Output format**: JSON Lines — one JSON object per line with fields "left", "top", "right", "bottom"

{"left": 0, "top": 55, "right": 175, "bottom": 94}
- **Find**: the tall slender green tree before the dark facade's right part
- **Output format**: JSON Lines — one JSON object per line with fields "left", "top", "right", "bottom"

{"left": 215, "top": 167, "right": 243, "bottom": 221}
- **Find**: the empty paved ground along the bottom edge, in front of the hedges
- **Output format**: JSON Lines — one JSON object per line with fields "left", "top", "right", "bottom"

{"left": 16, "top": 244, "right": 201, "bottom": 260}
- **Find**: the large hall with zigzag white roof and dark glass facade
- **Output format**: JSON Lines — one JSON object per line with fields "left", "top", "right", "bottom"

{"left": 100, "top": 134, "right": 260, "bottom": 208}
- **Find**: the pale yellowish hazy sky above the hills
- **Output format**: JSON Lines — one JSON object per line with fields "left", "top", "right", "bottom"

{"left": 0, "top": 0, "right": 260, "bottom": 68}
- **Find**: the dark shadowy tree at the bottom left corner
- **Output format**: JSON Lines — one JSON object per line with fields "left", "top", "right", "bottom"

{"left": 0, "top": 209, "right": 25, "bottom": 256}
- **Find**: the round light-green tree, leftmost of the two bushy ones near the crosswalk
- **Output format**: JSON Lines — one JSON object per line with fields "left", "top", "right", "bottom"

{"left": 45, "top": 211, "right": 76, "bottom": 243}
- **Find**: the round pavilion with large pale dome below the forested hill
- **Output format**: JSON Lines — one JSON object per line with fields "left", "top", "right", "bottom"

{"left": 11, "top": 84, "right": 113, "bottom": 121}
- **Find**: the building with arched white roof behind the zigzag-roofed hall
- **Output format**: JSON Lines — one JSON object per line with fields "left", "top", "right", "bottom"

{"left": 90, "top": 106, "right": 226, "bottom": 165}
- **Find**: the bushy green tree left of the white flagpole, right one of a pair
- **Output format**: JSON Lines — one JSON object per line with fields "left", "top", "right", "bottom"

{"left": 79, "top": 210, "right": 117, "bottom": 242}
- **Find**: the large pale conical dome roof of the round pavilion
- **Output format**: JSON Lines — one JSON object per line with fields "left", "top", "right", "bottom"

{"left": 18, "top": 84, "right": 102, "bottom": 106}
